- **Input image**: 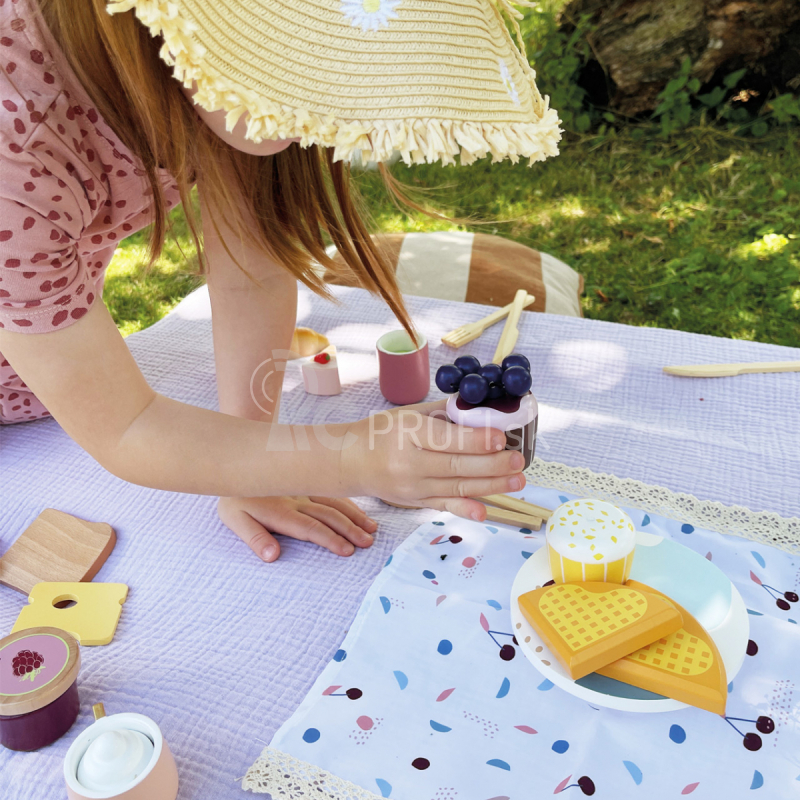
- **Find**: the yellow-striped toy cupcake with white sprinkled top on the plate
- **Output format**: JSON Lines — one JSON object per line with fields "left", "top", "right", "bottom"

{"left": 546, "top": 499, "right": 636, "bottom": 583}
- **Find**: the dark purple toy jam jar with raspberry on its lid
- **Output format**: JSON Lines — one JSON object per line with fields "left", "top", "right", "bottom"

{"left": 0, "top": 628, "right": 81, "bottom": 750}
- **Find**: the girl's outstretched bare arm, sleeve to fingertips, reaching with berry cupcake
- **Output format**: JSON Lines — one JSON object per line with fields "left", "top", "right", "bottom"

{"left": 0, "top": 302, "right": 524, "bottom": 506}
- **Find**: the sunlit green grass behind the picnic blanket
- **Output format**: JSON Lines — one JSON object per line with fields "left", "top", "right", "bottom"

{"left": 105, "top": 127, "right": 800, "bottom": 345}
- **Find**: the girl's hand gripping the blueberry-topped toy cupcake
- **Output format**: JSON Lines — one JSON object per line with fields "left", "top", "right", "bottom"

{"left": 341, "top": 402, "right": 525, "bottom": 521}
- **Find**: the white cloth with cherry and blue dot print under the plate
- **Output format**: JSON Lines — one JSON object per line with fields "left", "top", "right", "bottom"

{"left": 245, "top": 488, "right": 800, "bottom": 800}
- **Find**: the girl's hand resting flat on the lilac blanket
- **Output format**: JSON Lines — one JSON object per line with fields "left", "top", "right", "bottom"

{"left": 217, "top": 497, "right": 378, "bottom": 561}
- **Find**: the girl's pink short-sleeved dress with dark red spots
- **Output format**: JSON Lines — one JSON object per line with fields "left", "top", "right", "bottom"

{"left": 0, "top": 0, "right": 179, "bottom": 423}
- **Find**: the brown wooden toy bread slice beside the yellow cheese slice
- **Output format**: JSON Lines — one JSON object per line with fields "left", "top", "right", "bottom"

{"left": 0, "top": 508, "right": 117, "bottom": 596}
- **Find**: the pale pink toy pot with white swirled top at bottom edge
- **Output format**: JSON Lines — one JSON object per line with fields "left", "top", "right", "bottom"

{"left": 64, "top": 706, "right": 178, "bottom": 800}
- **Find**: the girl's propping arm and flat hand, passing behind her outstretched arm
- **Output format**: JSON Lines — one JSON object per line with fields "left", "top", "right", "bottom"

{"left": 201, "top": 195, "right": 378, "bottom": 561}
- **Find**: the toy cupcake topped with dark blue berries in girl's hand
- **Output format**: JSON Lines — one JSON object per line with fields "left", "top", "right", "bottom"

{"left": 436, "top": 353, "right": 539, "bottom": 469}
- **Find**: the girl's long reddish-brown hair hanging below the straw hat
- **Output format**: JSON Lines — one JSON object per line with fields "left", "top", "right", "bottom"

{"left": 38, "top": 0, "right": 416, "bottom": 336}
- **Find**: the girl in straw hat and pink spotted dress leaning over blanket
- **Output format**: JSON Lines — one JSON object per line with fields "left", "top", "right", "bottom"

{"left": 0, "top": 0, "right": 558, "bottom": 561}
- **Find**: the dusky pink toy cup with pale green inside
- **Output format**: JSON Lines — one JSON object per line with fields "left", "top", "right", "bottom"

{"left": 377, "top": 331, "right": 431, "bottom": 406}
